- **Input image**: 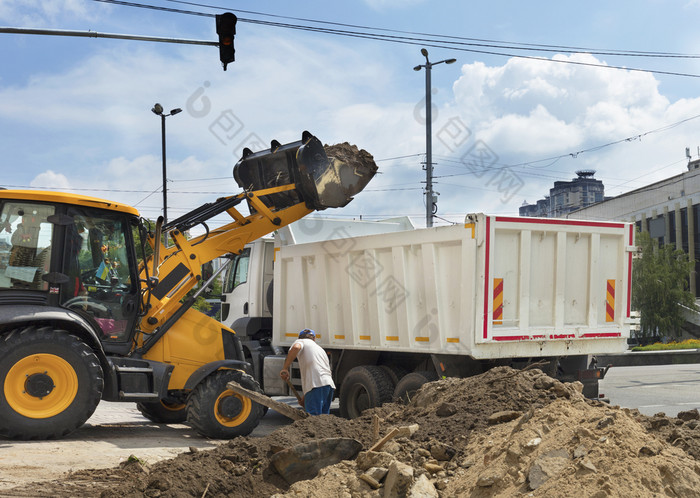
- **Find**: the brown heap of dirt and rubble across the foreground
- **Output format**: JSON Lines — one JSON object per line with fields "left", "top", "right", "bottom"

{"left": 6, "top": 367, "right": 700, "bottom": 497}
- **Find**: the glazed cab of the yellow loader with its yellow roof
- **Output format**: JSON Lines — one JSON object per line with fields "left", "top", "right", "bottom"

{"left": 0, "top": 191, "right": 139, "bottom": 349}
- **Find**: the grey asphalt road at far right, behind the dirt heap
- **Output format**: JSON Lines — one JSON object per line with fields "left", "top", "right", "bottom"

{"left": 600, "top": 364, "right": 700, "bottom": 417}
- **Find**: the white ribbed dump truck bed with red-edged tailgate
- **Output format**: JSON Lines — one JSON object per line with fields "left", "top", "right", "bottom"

{"left": 273, "top": 214, "right": 635, "bottom": 359}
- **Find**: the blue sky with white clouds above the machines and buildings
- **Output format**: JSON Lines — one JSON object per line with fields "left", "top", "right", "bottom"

{"left": 0, "top": 0, "right": 700, "bottom": 225}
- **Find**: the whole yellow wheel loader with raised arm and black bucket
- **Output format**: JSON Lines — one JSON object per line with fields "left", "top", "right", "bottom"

{"left": 0, "top": 132, "right": 376, "bottom": 439}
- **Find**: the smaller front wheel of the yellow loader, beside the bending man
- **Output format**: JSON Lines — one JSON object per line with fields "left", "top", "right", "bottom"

{"left": 187, "top": 370, "right": 263, "bottom": 439}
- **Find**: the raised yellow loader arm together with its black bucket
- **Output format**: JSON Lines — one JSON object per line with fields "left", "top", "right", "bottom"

{"left": 140, "top": 132, "right": 377, "bottom": 353}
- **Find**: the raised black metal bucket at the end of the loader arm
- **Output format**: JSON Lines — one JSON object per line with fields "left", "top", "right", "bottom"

{"left": 233, "top": 131, "right": 377, "bottom": 210}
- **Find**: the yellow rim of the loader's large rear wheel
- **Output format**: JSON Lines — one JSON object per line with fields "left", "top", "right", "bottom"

{"left": 4, "top": 353, "right": 78, "bottom": 418}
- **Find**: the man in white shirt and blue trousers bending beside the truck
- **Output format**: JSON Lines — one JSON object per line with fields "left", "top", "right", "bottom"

{"left": 280, "top": 329, "right": 335, "bottom": 415}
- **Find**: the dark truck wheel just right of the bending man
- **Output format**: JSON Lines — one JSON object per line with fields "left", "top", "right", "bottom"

{"left": 339, "top": 365, "right": 393, "bottom": 418}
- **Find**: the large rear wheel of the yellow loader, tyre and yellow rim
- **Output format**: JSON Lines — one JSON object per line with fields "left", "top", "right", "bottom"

{"left": 0, "top": 326, "right": 104, "bottom": 439}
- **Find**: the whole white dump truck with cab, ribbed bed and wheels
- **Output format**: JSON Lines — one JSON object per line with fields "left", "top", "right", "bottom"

{"left": 222, "top": 214, "right": 635, "bottom": 417}
